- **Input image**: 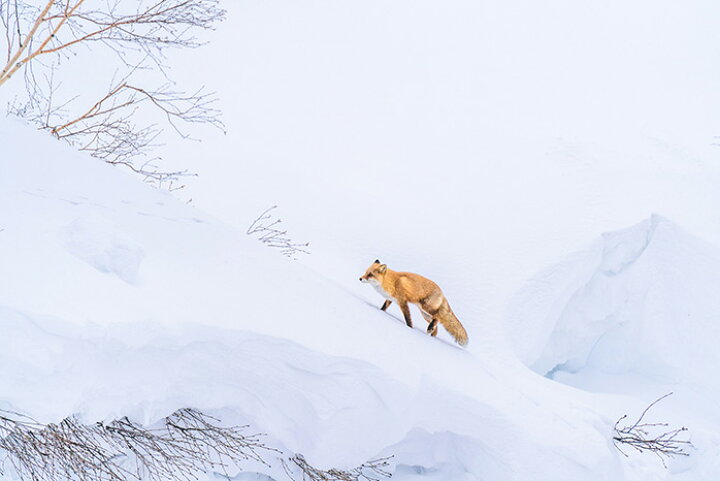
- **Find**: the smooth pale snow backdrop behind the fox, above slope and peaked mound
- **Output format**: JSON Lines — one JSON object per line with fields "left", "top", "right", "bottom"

{"left": 153, "top": 0, "right": 720, "bottom": 348}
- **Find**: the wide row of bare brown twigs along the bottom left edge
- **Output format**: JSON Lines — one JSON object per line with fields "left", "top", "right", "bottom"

{"left": 0, "top": 409, "right": 275, "bottom": 481}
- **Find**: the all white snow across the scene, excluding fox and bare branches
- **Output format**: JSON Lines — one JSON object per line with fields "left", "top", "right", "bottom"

{"left": 0, "top": 1, "right": 720, "bottom": 481}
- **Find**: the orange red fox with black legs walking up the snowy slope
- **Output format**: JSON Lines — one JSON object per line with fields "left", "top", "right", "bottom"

{"left": 360, "top": 259, "right": 468, "bottom": 346}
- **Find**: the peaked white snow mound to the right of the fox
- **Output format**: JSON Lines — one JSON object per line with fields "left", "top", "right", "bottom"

{"left": 507, "top": 215, "right": 720, "bottom": 387}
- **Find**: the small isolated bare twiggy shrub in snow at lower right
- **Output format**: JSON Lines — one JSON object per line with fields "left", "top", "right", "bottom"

{"left": 613, "top": 393, "right": 692, "bottom": 467}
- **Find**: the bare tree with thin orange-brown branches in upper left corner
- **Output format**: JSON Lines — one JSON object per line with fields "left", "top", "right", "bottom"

{"left": 0, "top": 0, "right": 225, "bottom": 188}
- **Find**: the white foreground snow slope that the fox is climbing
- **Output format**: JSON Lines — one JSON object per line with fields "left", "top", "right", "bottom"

{"left": 0, "top": 113, "right": 692, "bottom": 480}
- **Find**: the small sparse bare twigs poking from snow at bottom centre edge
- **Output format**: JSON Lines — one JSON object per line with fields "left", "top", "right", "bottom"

{"left": 283, "top": 454, "right": 392, "bottom": 481}
